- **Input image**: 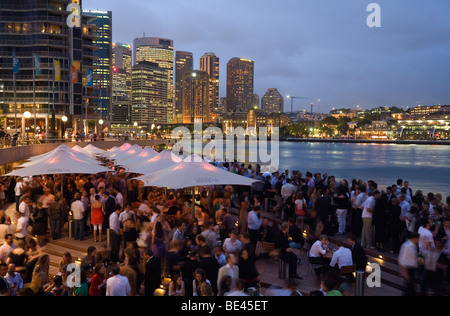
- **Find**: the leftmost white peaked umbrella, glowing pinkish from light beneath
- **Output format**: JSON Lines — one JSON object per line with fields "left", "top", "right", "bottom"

{"left": 7, "top": 149, "right": 111, "bottom": 177}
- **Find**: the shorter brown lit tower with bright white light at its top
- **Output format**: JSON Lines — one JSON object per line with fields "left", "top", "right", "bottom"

{"left": 182, "top": 70, "right": 210, "bottom": 124}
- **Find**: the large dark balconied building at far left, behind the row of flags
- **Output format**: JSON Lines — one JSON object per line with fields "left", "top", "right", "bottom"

{"left": 0, "top": 0, "right": 98, "bottom": 137}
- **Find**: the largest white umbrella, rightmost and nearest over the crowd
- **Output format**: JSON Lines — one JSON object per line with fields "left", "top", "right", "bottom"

{"left": 136, "top": 155, "right": 260, "bottom": 189}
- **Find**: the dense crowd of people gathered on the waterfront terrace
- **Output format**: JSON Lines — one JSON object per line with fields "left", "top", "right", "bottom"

{"left": 0, "top": 157, "right": 450, "bottom": 296}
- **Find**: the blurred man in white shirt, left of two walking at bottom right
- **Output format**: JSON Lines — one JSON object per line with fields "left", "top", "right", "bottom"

{"left": 398, "top": 232, "right": 419, "bottom": 296}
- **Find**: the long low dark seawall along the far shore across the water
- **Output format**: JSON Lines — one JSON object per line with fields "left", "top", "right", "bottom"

{"left": 280, "top": 137, "right": 450, "bottom": 146}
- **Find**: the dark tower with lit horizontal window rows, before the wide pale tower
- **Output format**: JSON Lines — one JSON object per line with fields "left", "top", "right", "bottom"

{"left": 131, "top": 61, "right": 172, "bottom": 125}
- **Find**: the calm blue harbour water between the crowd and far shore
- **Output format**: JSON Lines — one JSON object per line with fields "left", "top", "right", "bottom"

{"left": 279, "top": 142, "right": 450, "bottom": 199}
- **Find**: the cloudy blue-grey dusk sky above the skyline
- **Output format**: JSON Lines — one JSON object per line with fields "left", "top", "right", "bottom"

{"left": 83, "top": 0, "right": 450, "bottom": 112}
